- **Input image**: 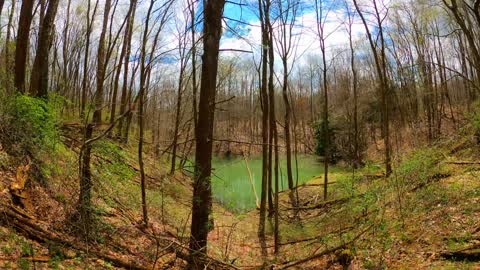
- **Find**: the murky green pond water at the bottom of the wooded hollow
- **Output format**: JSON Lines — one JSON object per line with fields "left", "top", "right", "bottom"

{"left": 212, "top": 156, "right": 323, "bottom": 213}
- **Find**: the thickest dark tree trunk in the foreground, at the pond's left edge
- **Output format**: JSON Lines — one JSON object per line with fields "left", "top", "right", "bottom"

{"left": 188, "top": 0, "right": 225, "bottom": 269}
